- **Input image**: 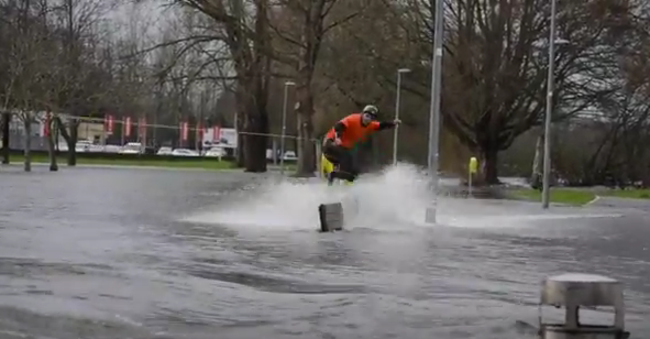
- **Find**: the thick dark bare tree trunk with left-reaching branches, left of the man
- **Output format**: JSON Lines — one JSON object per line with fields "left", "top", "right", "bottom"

{"left": 165, "top": 0, "right": 271, "bottom": 172}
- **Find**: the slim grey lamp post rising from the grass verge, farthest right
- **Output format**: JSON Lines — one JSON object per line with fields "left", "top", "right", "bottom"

{"left": 542, "top": 0, "right": 557, "bottom": 209}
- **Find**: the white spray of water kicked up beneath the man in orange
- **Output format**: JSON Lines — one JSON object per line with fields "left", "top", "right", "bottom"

{"left": 184, "top": 164, "right": 431, "bottom": 230}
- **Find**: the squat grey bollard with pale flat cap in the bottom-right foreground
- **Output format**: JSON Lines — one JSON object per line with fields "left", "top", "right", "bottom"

{"left": 539, "top": 273, "right": 630, "bottom": 339}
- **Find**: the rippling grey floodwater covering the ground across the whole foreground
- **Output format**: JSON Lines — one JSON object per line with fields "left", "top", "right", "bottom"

{"left": 0, "top": 167, "right": 650, "bottom": 339}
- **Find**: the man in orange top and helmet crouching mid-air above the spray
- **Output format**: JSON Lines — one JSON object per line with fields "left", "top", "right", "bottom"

{"left": 323, "top": 105, "right": 400, "bottom": 185}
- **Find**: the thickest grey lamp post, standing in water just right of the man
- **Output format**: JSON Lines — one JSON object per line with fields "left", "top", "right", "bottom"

{"left": 425, "top": 0, "right": 444, "bottom": 223}
